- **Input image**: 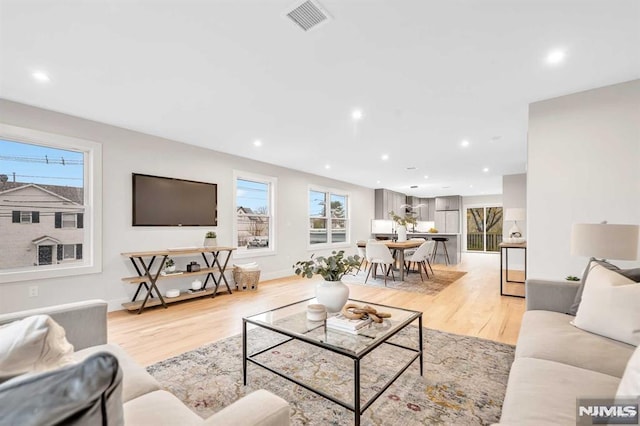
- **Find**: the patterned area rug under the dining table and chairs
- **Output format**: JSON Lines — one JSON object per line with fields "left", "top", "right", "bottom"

{"left": 342, "top": 267, "right": 466, "bottom": 296}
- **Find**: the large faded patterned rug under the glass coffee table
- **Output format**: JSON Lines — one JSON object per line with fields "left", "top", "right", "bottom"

{"left": 147, "top": 326, "right": 514, "bottom": 425}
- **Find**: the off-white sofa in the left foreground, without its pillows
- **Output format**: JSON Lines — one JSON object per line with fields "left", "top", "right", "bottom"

{"left": 0, "top": 300, "right": 289, "bottom": 426}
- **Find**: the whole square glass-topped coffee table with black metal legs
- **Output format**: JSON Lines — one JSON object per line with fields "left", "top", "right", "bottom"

{"left": 242, "top": 299, "right": 423, "bottom": 425}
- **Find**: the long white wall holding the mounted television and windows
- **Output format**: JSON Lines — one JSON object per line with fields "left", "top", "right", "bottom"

{"left": 0, "top": 99, "right": 374, "bottom": 313}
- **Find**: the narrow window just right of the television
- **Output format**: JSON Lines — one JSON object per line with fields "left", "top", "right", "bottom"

{"left": 234, "top": 173, "right": 276, "bottom": 257}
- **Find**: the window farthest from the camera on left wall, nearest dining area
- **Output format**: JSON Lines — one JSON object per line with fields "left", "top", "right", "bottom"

{"left": 309, "top": 189, "right": 349, "bottom": 246}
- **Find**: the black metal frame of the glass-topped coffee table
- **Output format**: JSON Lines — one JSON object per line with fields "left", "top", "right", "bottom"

{"left": 242, "top": 298, "right": 423, "bottom": 426}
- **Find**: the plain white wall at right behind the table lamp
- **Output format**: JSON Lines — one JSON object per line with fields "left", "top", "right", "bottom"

{"left": 527, "top": 80, "right": 640, "bottom": 280}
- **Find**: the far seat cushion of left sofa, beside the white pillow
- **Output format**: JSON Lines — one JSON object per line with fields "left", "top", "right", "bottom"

{"left": 74, "top": 344, "right": 161, "bottom": 402}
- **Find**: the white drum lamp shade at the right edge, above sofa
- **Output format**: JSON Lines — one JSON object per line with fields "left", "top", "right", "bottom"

{"left": 571, "top": 223, "right": 640, "bottom": 260}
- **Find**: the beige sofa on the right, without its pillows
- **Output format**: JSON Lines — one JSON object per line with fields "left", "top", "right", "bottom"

{"left": 500, "top": 280, "right": 635, "bottom": 426}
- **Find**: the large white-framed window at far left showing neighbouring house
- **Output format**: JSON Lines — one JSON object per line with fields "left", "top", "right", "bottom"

{"left": 0, "top": 124, "right": 102, "bottom": 283}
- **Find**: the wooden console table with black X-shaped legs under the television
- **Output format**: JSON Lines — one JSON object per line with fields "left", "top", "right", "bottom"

{"left": 122, "top": 247, "right": 235, "bottom": 314}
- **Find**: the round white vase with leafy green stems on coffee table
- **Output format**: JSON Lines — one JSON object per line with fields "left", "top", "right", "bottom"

{"left": 293, "top": 250, "right": 360, "bottom": 312}
